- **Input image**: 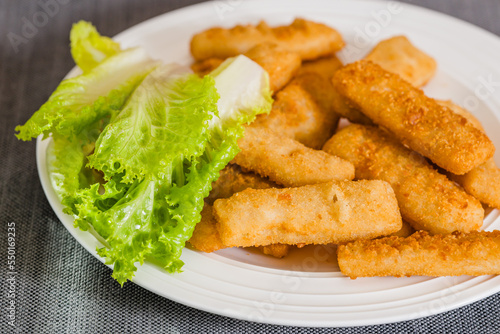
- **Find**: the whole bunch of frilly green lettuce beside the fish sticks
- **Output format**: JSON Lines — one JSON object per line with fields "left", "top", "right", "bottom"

{"left": 16, "top": 22, "right": 272, "bottom": 285}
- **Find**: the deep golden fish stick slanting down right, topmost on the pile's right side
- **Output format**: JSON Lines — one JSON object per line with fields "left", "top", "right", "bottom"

{"left": 333, "top": 61, "right": 495, "bottom": 175}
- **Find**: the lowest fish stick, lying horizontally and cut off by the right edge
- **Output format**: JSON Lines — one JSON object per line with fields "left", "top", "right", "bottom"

{"left": 337, "top": 231, "right": 500, "bottom": 279}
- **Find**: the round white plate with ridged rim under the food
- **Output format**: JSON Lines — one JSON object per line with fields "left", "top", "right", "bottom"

{"left": 37, "top": 0, "right": 500, "bottom": 327}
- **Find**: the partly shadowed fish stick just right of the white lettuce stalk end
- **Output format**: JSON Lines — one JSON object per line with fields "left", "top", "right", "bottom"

{"left": 250, "top": 74, "right": 339, "bottom": 149}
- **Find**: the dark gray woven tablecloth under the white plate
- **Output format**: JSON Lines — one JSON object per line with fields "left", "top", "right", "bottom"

{"left": 0, "top": 0, "right": 500, "bottom": 333}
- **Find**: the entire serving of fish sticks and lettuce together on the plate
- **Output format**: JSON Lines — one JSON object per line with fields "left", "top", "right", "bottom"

{"left": 16, "top": 19, "right": 500, "bottom": 284}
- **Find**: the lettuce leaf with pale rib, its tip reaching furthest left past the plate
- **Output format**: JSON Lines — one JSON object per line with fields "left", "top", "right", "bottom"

{"left": 16, "top": 48, "right": 157, "bottom": 140}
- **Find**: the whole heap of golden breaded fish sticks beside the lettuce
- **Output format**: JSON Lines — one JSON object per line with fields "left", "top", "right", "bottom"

{"left": 190, "top": 19, "right": 500, "bottom": 278}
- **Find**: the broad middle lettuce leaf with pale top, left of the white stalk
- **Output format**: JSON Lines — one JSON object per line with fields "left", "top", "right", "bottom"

{"left": 89, "top": 65, "right": 219, "bottom": 182}
